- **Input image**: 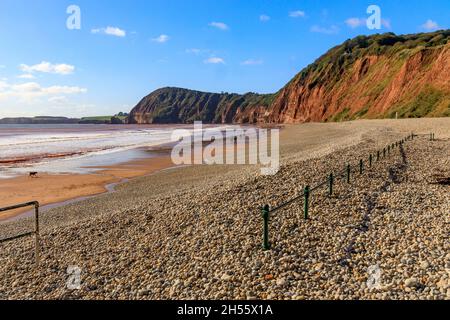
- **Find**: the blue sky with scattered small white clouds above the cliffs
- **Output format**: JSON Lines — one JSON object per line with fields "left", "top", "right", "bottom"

{"left": 0, "top": 0, "right": 450, "bottom": 117}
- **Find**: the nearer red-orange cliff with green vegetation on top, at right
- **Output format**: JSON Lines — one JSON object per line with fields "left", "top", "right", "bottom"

{"left": 269, "top": 32, "right": 450, "bottom": 123}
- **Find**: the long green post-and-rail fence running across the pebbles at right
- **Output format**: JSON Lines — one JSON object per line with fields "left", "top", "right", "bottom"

{"left": 261, "top": 133, "right": 435, "bottom": 250}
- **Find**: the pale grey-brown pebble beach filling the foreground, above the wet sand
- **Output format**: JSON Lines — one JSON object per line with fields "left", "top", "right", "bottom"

{"left": 0, "top": 118, "right": 450, "bottom": 300}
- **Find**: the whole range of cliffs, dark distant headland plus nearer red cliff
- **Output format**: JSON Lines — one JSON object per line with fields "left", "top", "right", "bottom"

{"left": 129, "top": 30, "right": 450, "bottom": 123}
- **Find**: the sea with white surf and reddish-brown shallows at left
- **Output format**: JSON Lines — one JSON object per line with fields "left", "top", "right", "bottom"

{"left": 0, "top": 124, "right": 232, "bottom": 179}
